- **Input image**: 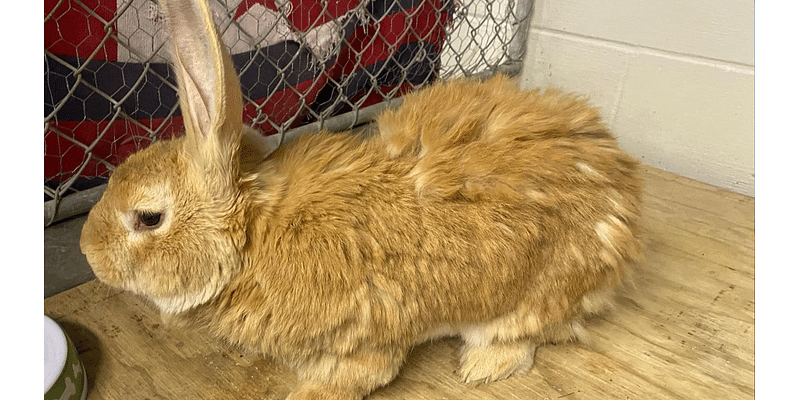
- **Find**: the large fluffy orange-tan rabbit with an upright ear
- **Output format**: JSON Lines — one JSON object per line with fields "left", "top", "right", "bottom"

{"left": 80, "top": 0, "right": 642, "bottom": 400}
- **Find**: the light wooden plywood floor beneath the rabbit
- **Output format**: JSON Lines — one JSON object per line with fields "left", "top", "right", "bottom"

{"left": 45, "top": 164, "right": 755, "bottom": 400}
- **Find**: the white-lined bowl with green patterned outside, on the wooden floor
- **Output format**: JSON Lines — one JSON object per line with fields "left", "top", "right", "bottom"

{"left": 44, "top": 315, "right": 87, "bottom": 400}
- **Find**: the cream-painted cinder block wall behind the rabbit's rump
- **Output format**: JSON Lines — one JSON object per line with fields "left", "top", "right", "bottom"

{"left": 522, "top": 0, "right": 755, "bottom": 196}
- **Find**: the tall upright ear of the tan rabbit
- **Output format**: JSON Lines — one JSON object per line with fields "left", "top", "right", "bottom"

{"left": 161, "top": 0, "right": 242, "bottom": 183}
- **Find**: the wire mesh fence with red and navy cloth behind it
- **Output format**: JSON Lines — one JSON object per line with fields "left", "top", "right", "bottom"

{"left": 44, "top": 0, "right": 533, "bottom": 226}
